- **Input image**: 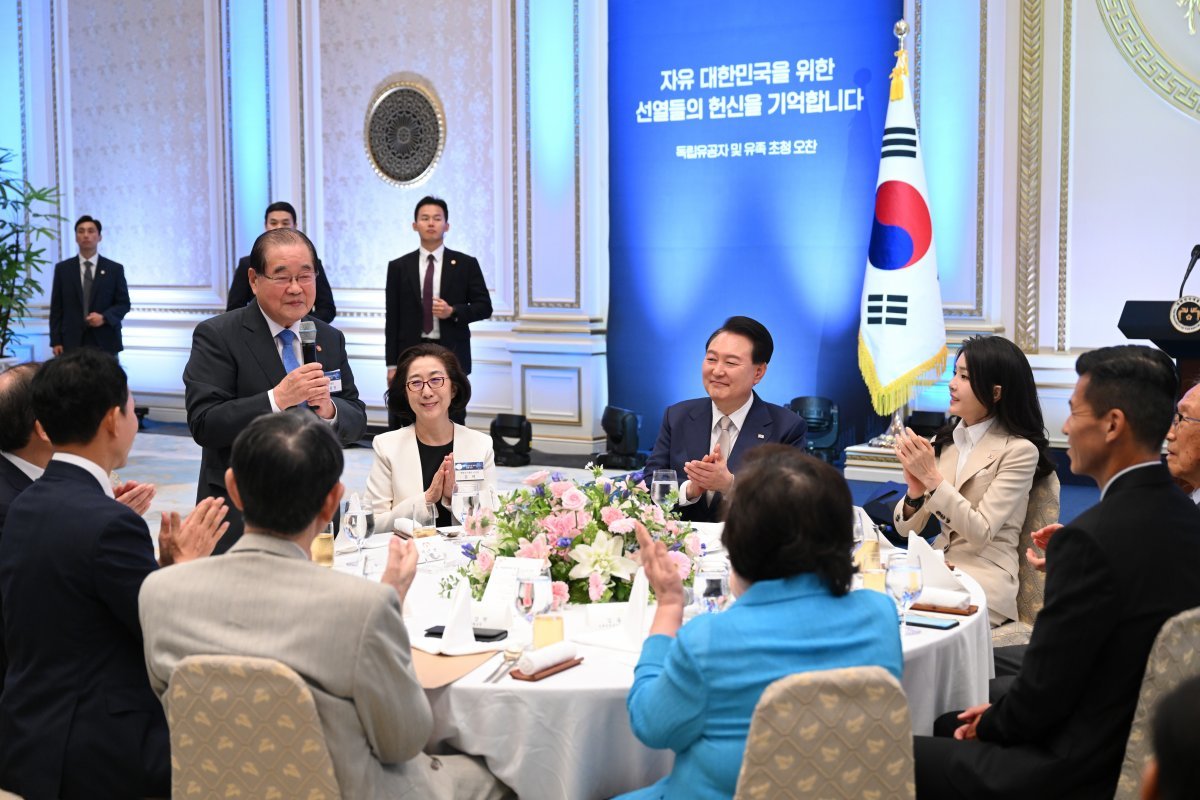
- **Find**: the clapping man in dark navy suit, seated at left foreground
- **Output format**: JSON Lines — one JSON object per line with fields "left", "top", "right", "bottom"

{"left": 0, "top": 348, "right": 223, "bottom": 800}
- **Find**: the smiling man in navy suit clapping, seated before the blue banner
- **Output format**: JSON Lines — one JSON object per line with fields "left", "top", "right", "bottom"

{"left": 646, "top": 317, "right": 808, "bottom": 522}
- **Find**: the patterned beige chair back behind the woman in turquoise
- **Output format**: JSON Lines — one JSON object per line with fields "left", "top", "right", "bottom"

{"left": 734, "top": 667, "right": 916, "bottom": 800}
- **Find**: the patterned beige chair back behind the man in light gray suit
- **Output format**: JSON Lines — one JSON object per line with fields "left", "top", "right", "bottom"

{"left": 166, "top": 656, "right": 341, "bottom": 800}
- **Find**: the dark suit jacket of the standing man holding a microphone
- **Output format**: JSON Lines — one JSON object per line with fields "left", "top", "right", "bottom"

{"left": 184, "top": 300, "right": 367, "bottom": 553}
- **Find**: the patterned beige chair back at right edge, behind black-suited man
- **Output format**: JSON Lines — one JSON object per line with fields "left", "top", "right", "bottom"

{"left": 1116, "top": 608, "right": 1200, "bottom": 800}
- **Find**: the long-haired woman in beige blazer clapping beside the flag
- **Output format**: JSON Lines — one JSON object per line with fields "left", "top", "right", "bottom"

{"left": 895, "top": 336, "right": 1054, "bottom": 626}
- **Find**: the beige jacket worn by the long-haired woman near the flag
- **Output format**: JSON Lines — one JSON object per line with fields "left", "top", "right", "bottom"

{"left": 895, "top": 421, "right": 1038, "bottom": 626}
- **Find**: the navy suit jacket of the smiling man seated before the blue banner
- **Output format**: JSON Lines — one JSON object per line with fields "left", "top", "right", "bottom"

{"left": 644, "top": 392, "right": 808, "bottom": 522}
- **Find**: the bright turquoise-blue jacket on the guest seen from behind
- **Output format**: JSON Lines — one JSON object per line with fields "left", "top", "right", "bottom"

{"left": 626, "top": 575, "right": 904, "bottom": 800}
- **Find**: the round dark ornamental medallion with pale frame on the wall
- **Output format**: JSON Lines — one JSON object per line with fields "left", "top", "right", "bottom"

{"left": 364, "top": 82, "right": 446, "bottom": 186}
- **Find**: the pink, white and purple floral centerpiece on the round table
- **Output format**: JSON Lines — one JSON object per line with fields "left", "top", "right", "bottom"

{"left": 443, "top": 464, "right": 701, "bottom": 607}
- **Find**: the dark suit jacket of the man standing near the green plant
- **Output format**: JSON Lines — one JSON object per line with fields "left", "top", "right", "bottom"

{"left": 50, "top": 253, "right": 130, "bottom": 355}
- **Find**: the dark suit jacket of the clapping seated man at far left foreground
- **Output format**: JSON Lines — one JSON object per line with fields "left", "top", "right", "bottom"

{"left": 0, "top": 461, "right": 170, "bottom": 800}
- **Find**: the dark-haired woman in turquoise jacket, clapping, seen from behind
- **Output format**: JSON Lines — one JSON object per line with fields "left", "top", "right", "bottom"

{"left": 628, "top": 445, "right": 904, "bottom": 798}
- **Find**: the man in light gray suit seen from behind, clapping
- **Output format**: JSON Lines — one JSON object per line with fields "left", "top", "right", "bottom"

{"left": 138, "top": 410, "right": 511, "bottom": 800}
